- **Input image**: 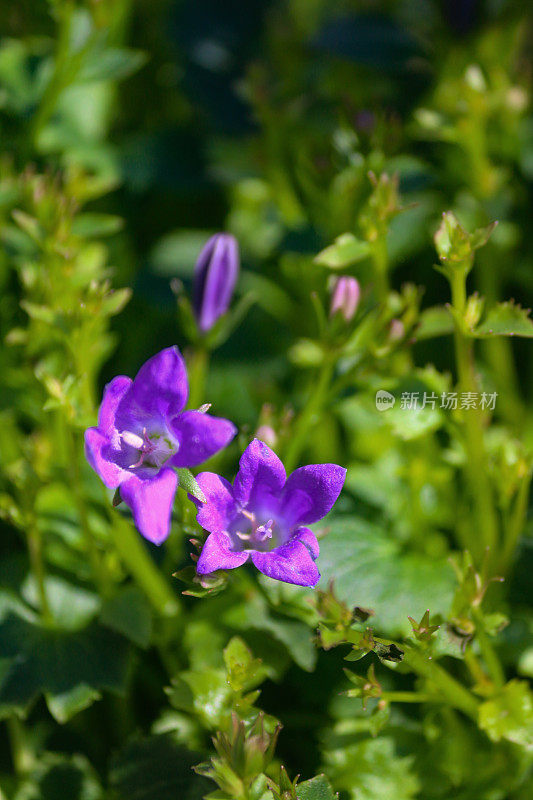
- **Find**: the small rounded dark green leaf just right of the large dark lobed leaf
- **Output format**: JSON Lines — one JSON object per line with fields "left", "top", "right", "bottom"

{"left": 100, "top": 586, "right": 152, "bottom": 647}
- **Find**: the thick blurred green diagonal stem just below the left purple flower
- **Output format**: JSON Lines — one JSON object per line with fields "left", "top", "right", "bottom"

{"left": 112, "top": 513, "right": 180, "bottom": 617}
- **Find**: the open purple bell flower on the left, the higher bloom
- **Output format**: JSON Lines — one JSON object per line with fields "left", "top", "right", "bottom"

{"left": 85, "top": 347, "right": 236, "bottom": 544}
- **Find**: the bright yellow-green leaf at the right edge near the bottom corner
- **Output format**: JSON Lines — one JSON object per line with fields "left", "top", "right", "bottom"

{"left": 479, "top": 680, "right": 533, "bottom": 748}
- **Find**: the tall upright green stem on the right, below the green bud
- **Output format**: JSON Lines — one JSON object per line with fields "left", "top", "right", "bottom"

{"left": 450, "top": 269, "right": 498, "bottom": 560}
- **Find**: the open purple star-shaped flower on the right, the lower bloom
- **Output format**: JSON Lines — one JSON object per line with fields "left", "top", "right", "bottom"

{"left": 192, "top": 439, "right": 346, "bottom": 586}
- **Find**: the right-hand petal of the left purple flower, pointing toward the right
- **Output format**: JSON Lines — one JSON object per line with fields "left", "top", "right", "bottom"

{"left": 170, "top": 411, "right": 237, "bottom": 467}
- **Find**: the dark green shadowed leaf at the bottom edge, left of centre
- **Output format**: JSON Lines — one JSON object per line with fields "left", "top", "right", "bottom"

{"left": 110, "top": 735, "right": 207, "bottom": 800}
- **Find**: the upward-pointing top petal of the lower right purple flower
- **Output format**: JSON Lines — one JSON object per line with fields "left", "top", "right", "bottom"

{"left": 233, "top": 439, "right": 287, "bottom": 510}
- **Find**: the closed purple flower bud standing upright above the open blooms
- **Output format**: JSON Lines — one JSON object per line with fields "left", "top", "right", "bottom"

{"left": 193, "top": 233, "right": 239, "bottom": 333}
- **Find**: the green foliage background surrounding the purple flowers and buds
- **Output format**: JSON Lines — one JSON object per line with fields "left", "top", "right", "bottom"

{"left": 0, "top": 0, "right": 533, "bottom": 800}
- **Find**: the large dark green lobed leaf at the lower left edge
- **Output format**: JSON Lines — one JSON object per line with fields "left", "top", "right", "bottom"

{"left": 0, "top": 614, "right": 130, "bottom": 722}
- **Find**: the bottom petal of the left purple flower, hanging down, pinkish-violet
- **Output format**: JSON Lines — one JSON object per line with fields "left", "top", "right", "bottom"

{"left": 120, "top": 468, "right": 178, "bottom": 544}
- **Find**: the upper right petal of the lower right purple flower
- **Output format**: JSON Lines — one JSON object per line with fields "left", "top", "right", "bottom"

{"left": 280, "top": 464, "right": 346, "bottom": 525}
